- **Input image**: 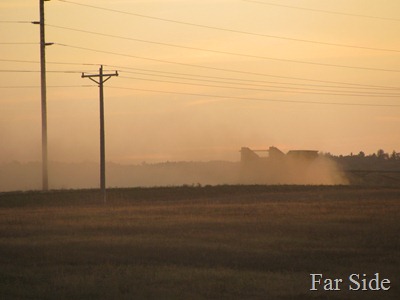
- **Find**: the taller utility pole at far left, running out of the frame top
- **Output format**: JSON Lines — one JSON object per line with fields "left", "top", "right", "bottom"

{"left": 32, "top": 0, "right": 53, "bottom": 191}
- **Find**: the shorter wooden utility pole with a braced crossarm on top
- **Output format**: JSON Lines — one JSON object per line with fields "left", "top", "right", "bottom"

{"left": 82, "top": 66, "right": 118, "bottom": 203}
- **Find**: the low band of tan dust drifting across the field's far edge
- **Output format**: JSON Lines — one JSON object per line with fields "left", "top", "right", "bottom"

{"left": 0, "top": 152, "right": 348, "bottom": 192}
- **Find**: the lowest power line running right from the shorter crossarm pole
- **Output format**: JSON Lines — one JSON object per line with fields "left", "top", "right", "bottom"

{"left": 109, "top": 86, "right": 400, "bottom": 107}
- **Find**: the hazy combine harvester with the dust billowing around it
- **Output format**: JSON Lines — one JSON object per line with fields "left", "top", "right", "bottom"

{"left": 240, "top": 147, "right": 346, "bottom": 185}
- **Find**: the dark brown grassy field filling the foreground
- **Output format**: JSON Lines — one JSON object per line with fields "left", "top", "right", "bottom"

{"left": 0, "top": 186, "right": 400, "bottom": 299}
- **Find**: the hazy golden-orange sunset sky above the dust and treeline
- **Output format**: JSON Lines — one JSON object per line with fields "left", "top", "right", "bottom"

{"left": 0, "top": 0, "right": 400, "bottom": 164}
